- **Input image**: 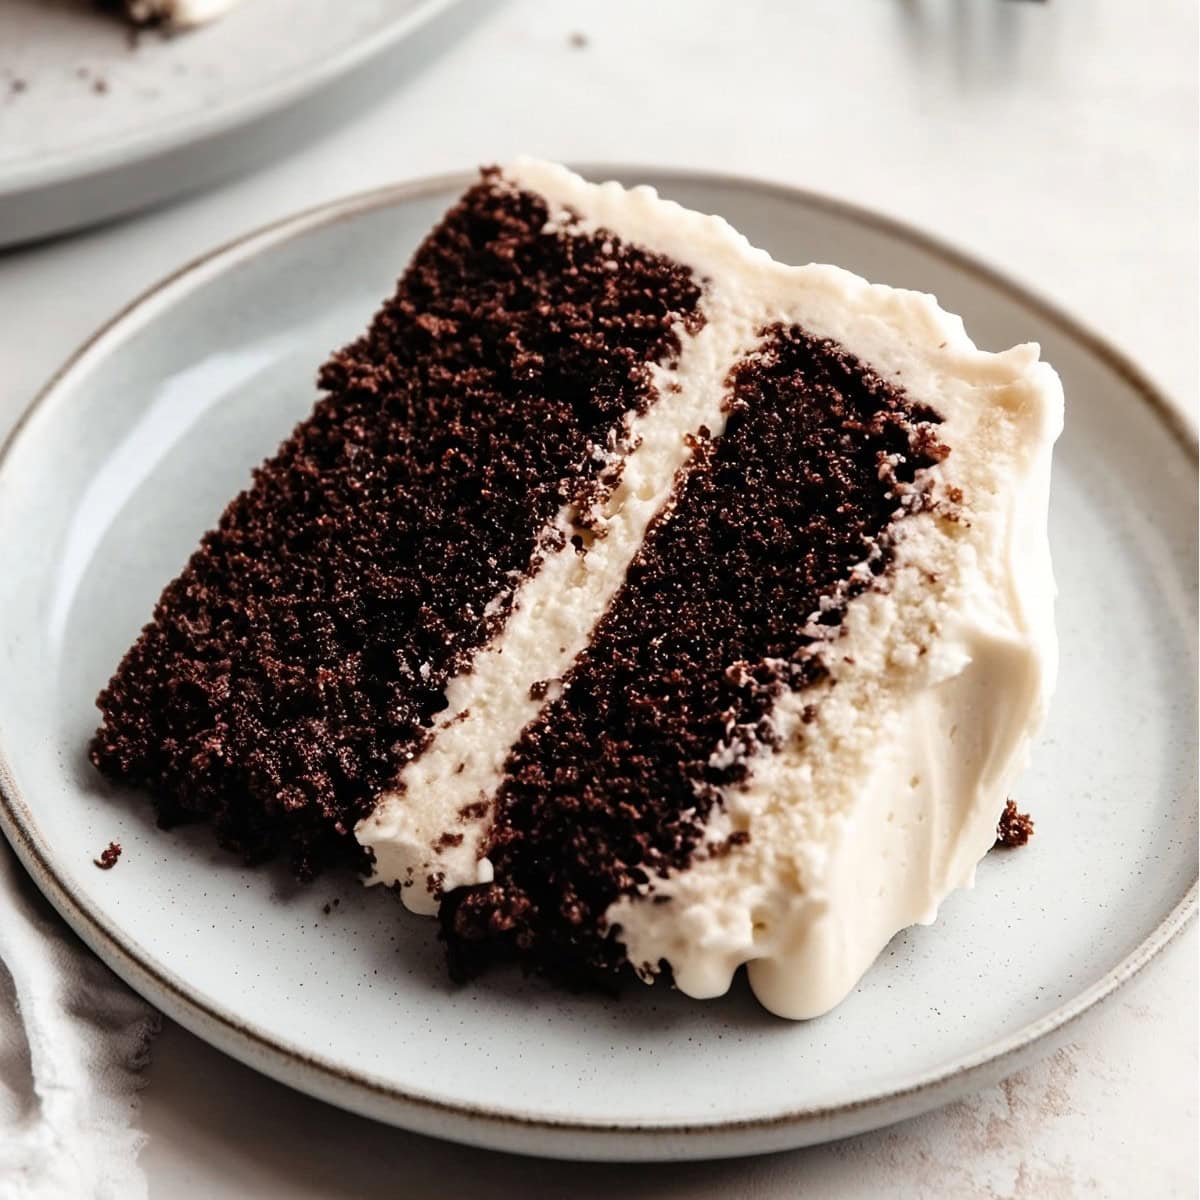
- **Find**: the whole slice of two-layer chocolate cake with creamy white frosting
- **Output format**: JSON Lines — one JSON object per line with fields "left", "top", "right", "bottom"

{"left": 92, "top": 161, "right": 1062, "bottom": 1016}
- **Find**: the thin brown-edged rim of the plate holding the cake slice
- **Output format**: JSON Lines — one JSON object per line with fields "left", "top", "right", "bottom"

{"left": 0, "top": 169, "right": 1200, "bottom": 1157}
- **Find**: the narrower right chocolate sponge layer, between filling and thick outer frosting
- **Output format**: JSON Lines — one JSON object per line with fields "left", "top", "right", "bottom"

{"left": 442, "top": 326, "right": 944, "bottom": 979}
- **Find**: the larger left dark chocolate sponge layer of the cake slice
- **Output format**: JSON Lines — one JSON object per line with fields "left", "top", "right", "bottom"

{"left": 91, "top": 173, "right": 702, "bottom": 876}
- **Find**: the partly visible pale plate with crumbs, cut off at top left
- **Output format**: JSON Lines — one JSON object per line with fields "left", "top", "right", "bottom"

{"left": 0, "top": 0, "right": 463, "bottom": 246}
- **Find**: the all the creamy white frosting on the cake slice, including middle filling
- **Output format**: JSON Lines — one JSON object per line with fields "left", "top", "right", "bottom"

{"left": 356, "top": 161, "right": 1062, "bottom": 1016}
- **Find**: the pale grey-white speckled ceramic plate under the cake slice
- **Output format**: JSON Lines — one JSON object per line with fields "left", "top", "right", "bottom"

{"left": 0, "top": 169, "right": 1196, "bottom": 1158}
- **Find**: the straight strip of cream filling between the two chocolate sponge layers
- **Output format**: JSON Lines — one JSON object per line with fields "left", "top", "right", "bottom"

{"left": 355, "top": 299, "right": 755, "bottom": 914}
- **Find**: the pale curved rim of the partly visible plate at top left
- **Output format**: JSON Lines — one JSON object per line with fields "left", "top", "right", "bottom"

{"left": 0, "top": 0, "right": 458, "bottom": 193}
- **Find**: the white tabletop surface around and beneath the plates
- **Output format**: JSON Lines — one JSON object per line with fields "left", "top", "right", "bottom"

{"left": 0, "top": 0, "right": 1198, "bottom": 1200}
